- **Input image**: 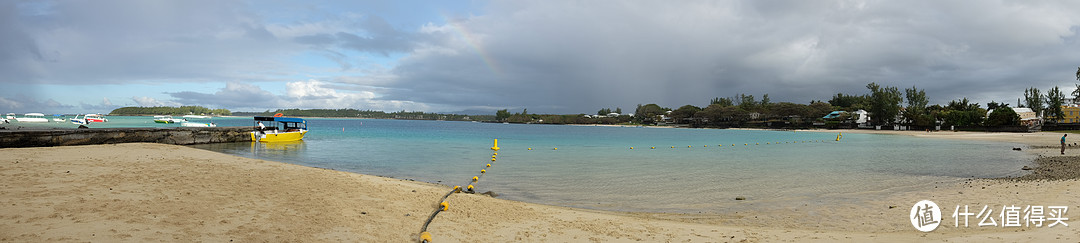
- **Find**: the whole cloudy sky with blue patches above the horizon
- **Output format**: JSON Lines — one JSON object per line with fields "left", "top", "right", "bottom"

{"left": 0, "top": 0, "right": 1080, "bottom": 114}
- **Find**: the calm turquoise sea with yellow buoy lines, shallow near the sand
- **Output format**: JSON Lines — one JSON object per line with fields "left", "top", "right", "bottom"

{"left": 4, "top": 117, "right": 1034, "bottom": 213}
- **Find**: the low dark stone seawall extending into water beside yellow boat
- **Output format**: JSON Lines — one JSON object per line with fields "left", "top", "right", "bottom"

{"left": 0, "top": 126, "right": 252, "bottom": 148}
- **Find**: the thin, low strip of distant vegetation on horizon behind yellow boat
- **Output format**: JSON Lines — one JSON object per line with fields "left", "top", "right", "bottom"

{"left": 233, "top": 109, "right": 494, "bottom": 121}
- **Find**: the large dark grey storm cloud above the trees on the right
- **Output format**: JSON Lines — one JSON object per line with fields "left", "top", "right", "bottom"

{"left": 369, "top": 1, "right": 1080, "bottom": 112}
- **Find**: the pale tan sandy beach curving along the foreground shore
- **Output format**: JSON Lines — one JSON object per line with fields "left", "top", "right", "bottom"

{"left": 0, "top": 131, "right": 1080, "bottom": 242}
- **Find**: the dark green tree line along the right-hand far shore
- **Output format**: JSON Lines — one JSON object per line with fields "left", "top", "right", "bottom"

{"left": 495, "top": 77, "right": 1080, "bottom": 129}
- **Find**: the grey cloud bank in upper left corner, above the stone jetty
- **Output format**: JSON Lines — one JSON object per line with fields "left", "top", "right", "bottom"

{"left": 0, "top": 0, "right": 429, "bottom": 84}
